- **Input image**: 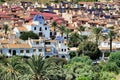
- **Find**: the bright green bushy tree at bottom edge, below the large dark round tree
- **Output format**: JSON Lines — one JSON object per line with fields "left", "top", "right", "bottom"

{"left": 64, "top": 62, "right": 94, "bottom": 80}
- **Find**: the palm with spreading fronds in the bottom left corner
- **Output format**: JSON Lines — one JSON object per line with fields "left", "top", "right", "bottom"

{"left": 0, "top": 56, "right": 28, "bottom": 80}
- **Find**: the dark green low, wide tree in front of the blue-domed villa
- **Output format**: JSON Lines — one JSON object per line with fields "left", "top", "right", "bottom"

{"left": 20, "top": 31, "right": 39, "bottom": 40}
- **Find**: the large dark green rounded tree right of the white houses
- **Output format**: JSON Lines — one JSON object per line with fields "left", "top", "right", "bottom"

{"left": 78, "top": 41, "right": 101, "bottom": 60}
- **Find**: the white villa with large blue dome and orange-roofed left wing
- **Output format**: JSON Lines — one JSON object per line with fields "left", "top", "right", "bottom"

{"left": 13, "top": 14, "right": 50, "bottom": 39}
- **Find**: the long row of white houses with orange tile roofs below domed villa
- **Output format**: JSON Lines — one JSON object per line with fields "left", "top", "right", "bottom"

{"left": 0, "top": 38, "right": 70, "bottom": 60}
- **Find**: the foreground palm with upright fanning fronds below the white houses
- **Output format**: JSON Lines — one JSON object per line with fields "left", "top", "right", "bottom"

{"left": 26, "top": 56, "right": 45, "bottom": 80}
